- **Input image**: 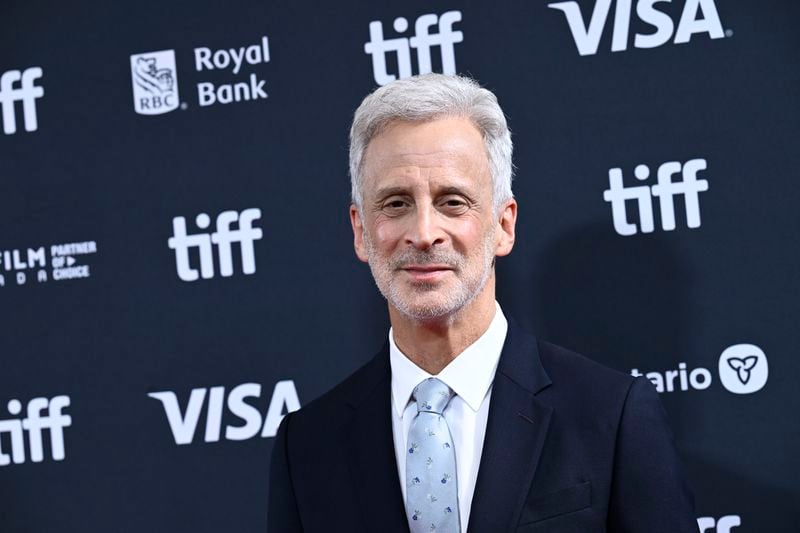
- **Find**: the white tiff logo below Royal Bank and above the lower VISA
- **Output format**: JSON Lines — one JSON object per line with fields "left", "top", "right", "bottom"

{"left": 167, "top": 208, "right": 262, "bottom": 281}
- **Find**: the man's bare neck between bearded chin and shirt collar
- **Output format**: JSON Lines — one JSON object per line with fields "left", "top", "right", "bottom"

{"left": 389, "top": 274, "right": 496, "bottom": 375}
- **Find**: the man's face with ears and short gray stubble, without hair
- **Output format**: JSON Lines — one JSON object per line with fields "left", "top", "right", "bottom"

{"left": 350, "top": 118, "right": 516, "bottom": 320}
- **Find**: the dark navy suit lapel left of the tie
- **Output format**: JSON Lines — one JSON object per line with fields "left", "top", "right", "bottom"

{"left": 342, "top": 345, "right": 409, "bottom": 533}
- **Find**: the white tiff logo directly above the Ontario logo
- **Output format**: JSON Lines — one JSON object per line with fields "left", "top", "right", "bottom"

{"left": 603, "top": 159, "right": 708, "bottom": 236}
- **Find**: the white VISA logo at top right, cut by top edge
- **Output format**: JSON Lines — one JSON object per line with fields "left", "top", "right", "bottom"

{"left": 547, "top": 0, "right": 733, "bottom": 56}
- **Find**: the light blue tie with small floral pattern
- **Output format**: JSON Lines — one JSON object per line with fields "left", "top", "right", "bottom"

{"left": 406, "top": 378, "right": 461, "bottom": 533}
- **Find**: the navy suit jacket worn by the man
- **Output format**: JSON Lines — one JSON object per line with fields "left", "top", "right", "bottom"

{"left": 268, "top": 319, "right": 698, "bottom": 533}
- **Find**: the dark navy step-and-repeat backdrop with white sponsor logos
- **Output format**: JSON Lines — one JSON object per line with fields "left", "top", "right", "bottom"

{"left": 0, "top": 0, "right": 800, "bottom": 533}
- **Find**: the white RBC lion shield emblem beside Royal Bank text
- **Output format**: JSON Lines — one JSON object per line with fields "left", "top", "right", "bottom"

{"left": 131, "top": 50, "right": 180, "bottom": 115}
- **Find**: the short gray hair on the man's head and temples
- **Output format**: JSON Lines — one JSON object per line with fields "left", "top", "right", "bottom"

{"left": 350, "top": 74, "right": 514, "bottom": 211}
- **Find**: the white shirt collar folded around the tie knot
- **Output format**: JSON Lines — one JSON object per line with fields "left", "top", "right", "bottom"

{"left": 389, "top": 302, "right": 508, "bottom": 418}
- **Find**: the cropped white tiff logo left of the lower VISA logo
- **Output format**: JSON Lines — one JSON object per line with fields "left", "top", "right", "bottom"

{"left": 0, "top": 396, "right": 72, "bottom": 466}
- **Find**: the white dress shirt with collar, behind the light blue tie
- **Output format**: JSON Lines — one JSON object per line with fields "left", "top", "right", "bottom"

{"left": 389, "top": 302, "right": 508, "bottom": 531}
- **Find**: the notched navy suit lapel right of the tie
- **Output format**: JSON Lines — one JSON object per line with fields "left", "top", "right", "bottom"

{"left": 468, "top": 318, "right": 553, "bottom": 533}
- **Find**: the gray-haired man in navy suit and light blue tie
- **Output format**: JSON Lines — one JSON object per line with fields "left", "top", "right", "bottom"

{"left": 269, "top": 74, "right": 697, "bottom": 533}
